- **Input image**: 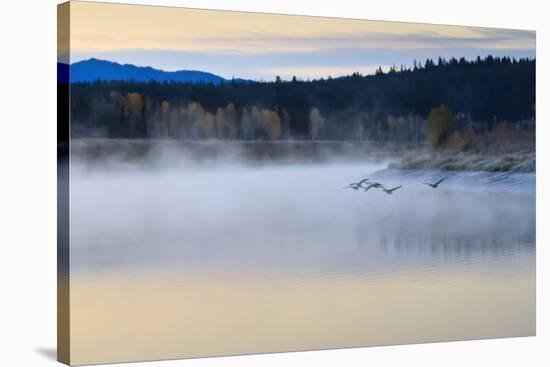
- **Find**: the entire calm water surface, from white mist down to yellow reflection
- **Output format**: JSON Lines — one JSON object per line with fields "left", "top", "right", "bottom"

{"left": 67, "top": 163, "right": 535, "bottom": 363}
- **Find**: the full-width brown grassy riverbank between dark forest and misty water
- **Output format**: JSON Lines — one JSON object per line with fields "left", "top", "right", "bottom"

{"left": 71, "top": 139, "right": 536, "bottom": 172}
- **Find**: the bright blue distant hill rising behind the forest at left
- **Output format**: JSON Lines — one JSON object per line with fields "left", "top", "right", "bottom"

{"left": 68, "top": 58, "right": 229, "bottom": 84}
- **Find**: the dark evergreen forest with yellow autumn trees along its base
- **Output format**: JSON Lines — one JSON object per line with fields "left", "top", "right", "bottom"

{"left": 70, "top": 56, "right": 535, "bottom": 145}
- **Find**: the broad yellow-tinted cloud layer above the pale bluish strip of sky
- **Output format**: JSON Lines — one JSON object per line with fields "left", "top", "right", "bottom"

{"left": 71, "top": 2, "right": 535, "bottom": 54}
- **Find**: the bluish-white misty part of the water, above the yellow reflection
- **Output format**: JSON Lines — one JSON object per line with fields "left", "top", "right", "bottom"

{"left": 71, "top": 144, "right": 535, "bottom": 272}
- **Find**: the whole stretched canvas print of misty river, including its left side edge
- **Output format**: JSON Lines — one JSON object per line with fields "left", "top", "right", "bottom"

{"left": 57, "top": 1, "right": 536, "bottom": 365}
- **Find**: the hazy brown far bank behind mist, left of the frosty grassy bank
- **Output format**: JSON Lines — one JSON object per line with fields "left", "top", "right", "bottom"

{"left": 70, "top": 139, "right": 425, "bottom": 165}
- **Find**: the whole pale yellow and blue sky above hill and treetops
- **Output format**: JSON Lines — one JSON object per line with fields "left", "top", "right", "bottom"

{"left": 59, "top": 1, "right": 535, "bottom": 80}
